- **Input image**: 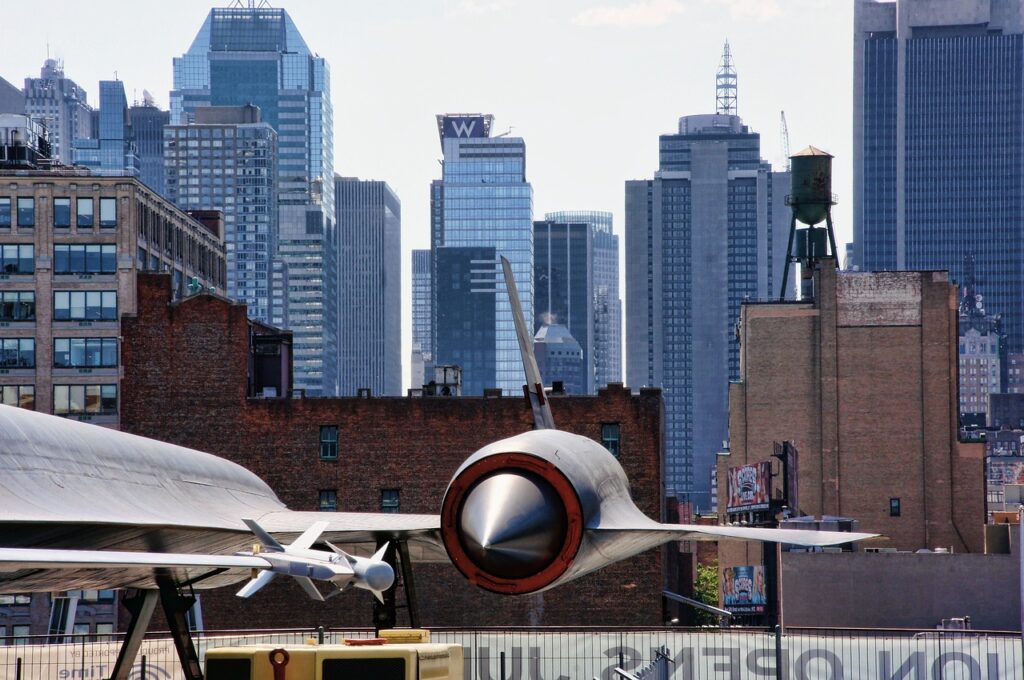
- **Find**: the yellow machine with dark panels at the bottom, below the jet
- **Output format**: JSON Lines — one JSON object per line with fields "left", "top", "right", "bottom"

{"left": 206, "top": 631, "right": 463, "bottom": 680}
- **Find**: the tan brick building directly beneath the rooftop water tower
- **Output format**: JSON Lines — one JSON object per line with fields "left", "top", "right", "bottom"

{"left": 718, "top": 266, "right": 985, "bottom": 564}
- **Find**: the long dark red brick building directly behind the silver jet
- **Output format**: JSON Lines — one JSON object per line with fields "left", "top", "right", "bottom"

{"left": 122, "top": 275, "right": 664, "bottom": 629}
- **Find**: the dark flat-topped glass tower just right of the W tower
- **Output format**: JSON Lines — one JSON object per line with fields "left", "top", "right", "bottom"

{"left": 532, "top": 220, "right": 594, "bottom": 394}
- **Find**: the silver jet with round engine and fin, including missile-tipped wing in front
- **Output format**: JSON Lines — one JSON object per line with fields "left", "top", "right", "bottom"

{"left": 0, "top": 257, "right": 876, "bottom": 680}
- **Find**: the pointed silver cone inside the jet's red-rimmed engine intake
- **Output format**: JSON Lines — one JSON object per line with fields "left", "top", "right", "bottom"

{"left": 460, "top": 470, "right": 567, "bottom": 579}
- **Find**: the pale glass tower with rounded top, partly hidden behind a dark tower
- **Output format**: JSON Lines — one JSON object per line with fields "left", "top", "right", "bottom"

{"left": 544, "top": 210, "right": 623, "bottom": 387}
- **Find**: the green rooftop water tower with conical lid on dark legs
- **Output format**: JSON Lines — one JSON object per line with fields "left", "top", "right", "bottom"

{"left": 778, "top": 146, "right": 839, "bottom": 300}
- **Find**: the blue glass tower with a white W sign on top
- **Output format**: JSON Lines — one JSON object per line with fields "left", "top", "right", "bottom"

{"left": 430, "top": 114, "right": 534, "bottom": 395}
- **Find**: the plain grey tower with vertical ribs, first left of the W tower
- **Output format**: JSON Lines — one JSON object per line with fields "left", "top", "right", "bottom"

{"left": 334, "top": 177, "right": 401, "bottom": 396}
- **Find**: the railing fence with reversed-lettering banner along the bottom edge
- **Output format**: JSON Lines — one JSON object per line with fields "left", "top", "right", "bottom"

{"left": 0, "top": 628, "right": 1024, "bottom": 680}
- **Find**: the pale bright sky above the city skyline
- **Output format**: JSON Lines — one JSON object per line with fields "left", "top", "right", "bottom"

{"left": 0, "top": 0, "right": 853, "bottom": 385}
